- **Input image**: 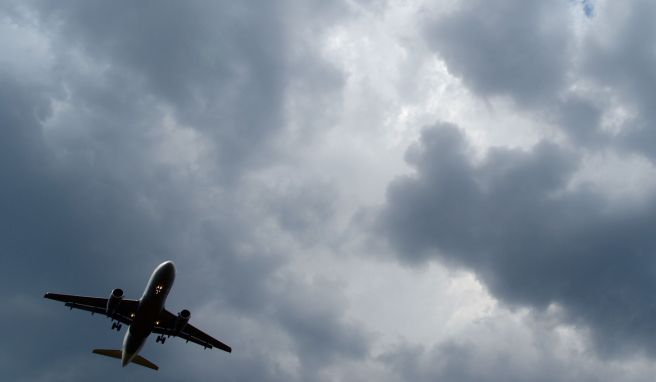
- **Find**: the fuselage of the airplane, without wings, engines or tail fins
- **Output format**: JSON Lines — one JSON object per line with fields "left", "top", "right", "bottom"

{"left": 121, "top": 261, "right": 175, "bottom": 366}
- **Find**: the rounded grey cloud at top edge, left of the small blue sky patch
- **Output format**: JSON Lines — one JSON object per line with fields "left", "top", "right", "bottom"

{"left": 424, "top": 0, "right": 610, "bottom": 152}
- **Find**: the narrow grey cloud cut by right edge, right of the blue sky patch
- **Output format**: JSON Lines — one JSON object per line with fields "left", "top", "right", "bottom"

{"left": 582, "top": 1, "right": 656, "bottom": 161}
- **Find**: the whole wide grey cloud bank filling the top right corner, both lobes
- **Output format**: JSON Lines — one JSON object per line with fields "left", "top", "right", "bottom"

{"left": 424, "top": 0, "right": 656, "bottom": 160}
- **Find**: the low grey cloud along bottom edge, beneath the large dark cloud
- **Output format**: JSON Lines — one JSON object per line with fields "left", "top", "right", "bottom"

{"left": 379, "top": 315, "right": 651, "bottom": 382}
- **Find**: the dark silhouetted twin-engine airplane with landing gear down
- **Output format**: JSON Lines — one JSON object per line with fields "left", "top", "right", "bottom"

{"left": 43, "top": 261, "right": 232, "bottom": 370}
